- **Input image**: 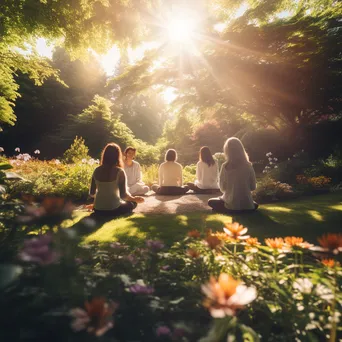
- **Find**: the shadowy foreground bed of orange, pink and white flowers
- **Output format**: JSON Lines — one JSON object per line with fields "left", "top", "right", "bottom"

{"left": 0, "top": 199, "right": 342, "bottom": 342}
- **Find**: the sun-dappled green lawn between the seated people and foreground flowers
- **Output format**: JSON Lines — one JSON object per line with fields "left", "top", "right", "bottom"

{"left": 68, "top": 192, "right": 342, "bottom": 245}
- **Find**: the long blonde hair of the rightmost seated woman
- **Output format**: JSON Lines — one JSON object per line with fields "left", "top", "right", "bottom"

{"left": 223, "top": 137, "right": 250, "bottom": 169}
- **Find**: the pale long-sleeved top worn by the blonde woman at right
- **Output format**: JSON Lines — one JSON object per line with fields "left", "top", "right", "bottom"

{"left": 219, "top": 163, "right": 256, "bottom": 210}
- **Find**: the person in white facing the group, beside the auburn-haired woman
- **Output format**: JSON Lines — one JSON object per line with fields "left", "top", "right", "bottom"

{"left": 124, "top": 146, "right": 150, "bottom": 195}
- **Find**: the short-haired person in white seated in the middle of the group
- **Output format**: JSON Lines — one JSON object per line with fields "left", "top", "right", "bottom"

{"left": 152, "top": 149, "right": 189, "bottom": 195}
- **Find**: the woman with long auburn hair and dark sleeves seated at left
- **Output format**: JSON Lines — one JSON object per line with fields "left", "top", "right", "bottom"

{"left": 89, "top": 143, "right": 144, "bottom": 216}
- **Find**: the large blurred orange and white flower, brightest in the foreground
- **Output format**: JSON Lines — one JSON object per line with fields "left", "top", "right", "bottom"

{"left": 202, "top": 273, "right": 257, "bottom": 318}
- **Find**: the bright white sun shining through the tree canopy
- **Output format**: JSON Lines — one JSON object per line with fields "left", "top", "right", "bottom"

{"left": 167, "top": 13, "right": 196, "bottom": 43}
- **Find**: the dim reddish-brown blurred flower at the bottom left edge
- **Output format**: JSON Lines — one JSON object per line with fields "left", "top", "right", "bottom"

{"left": 70, "top": 297, "right": 118, "bottom": 336}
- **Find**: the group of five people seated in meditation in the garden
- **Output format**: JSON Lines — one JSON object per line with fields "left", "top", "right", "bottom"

{"left": 89, "top": 138, "right": 258, "bottom": 216}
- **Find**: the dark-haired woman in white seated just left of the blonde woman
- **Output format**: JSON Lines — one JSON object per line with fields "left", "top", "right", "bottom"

{"left": 188, "top": 146, "right": 219, "bottom": 194}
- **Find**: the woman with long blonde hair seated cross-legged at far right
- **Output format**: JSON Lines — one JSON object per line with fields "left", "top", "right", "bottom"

{"left": 208, "top": 138, "right": 258, "bottom": 213}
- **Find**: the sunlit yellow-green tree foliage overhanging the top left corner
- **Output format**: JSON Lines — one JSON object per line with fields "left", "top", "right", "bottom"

{"left": 0, "top": 0, "right": 159, "bottom": 125}
